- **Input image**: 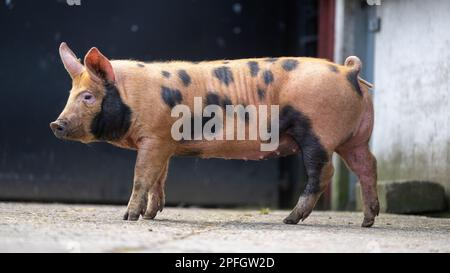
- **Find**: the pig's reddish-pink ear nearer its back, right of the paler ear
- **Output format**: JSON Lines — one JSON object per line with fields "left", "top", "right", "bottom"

{"left": 84, "top": 47, "right": 115, "bottom": 83}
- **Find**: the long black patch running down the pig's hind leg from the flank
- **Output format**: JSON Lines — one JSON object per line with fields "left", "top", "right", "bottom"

{"left": 280, "top": 105, "right": 328, "bottom": 194}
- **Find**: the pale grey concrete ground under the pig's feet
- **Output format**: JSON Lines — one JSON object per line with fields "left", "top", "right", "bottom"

{"left": 0, "top": 203, "right": 450, "bottom": 252}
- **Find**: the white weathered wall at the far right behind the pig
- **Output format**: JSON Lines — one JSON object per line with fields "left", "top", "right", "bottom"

{"left": 372, "top": 0, "right": 450, "bottom": 200}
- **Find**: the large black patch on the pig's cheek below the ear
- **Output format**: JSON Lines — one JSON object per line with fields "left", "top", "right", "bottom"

{"left": 90, "top": 84, "right": 131, "bottom": 141}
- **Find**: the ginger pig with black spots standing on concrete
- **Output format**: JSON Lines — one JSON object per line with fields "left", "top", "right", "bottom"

{"left": 50, "top": 43, "right": 379, "bottom": 227}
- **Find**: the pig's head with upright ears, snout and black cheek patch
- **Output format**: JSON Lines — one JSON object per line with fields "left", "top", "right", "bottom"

{"left": 50, "top": 43, "right": 131, "bottom": 143}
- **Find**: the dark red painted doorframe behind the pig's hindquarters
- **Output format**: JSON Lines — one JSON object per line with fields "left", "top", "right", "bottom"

{"left": 317, "top": 0, "right": 336, "bottom": 209}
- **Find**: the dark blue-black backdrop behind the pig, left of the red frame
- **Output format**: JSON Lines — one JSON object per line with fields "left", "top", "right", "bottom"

{"left": 0, "top": 0, "right": 318, "bottom": 207}
